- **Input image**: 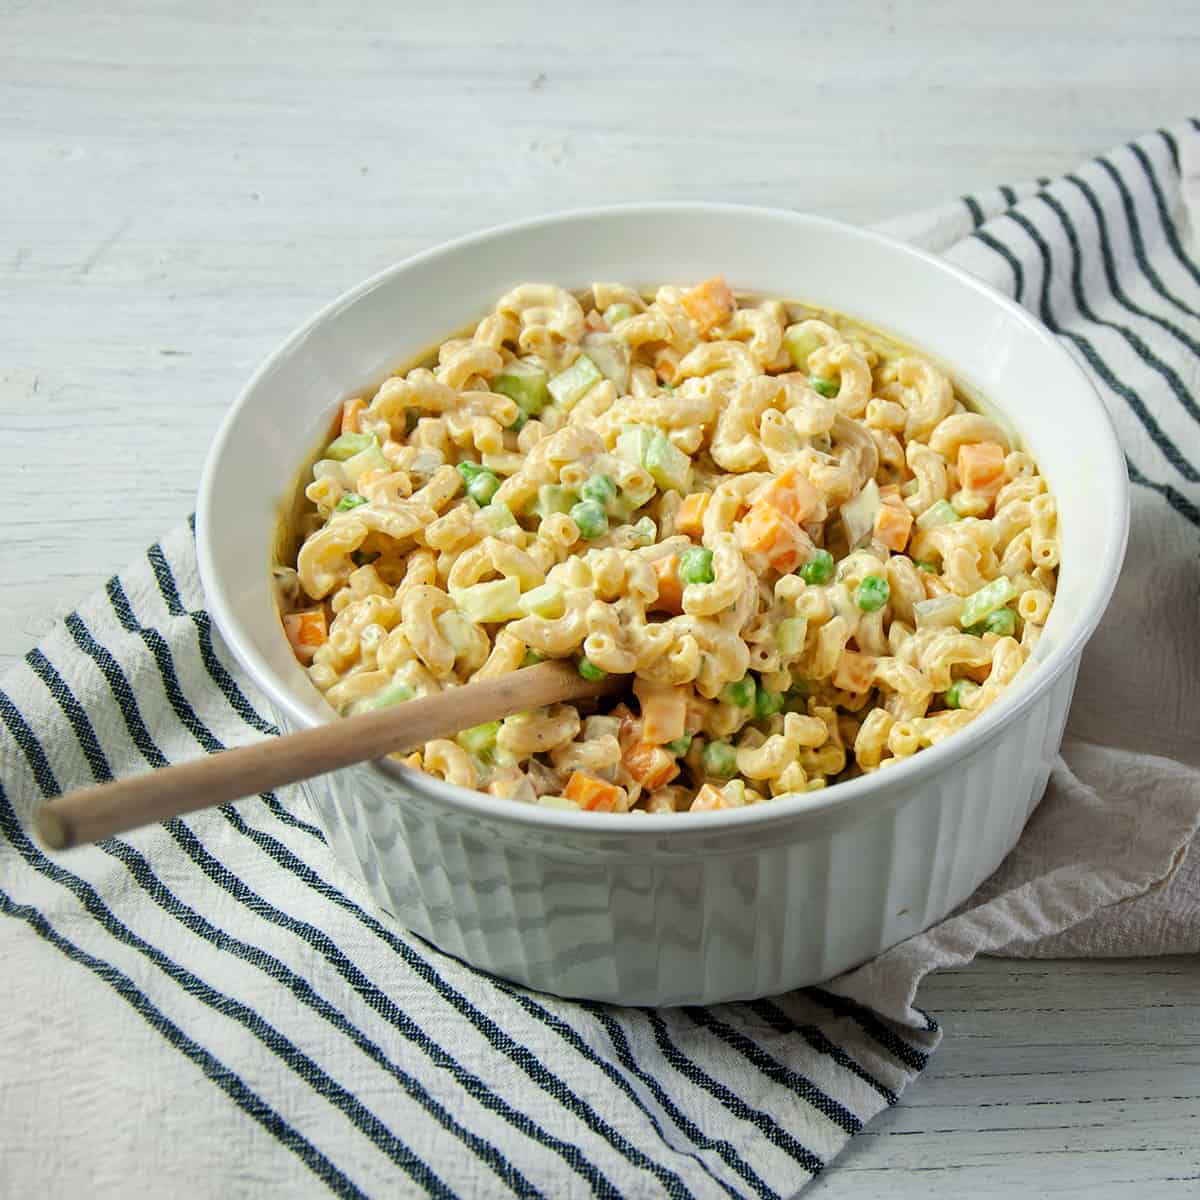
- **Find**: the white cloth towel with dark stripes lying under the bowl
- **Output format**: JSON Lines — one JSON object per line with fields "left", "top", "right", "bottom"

{"left": 0, "top": 124, "right": 1200, "bottom": 1200}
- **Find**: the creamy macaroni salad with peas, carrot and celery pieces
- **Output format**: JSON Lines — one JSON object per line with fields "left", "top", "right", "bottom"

{"left": 276, "top": 277, "right": 1058, "bottom": 812}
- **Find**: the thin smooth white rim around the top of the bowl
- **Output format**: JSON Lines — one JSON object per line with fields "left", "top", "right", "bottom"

{"left": 196, "top": 200, "right": 1130, "bottom": 840}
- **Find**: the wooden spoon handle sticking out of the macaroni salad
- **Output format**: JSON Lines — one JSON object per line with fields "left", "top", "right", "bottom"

{"left": 34, "top": 661, "right": 626, "bottom": 850}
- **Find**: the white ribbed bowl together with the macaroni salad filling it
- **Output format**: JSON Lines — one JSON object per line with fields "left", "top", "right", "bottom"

{"left": 197, "top": 205, "right": 1128, "bottom": 1004}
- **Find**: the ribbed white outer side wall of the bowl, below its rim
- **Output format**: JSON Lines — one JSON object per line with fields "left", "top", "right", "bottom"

{"left": 288, "top": 659, "right": 1079, "bottom": 1004}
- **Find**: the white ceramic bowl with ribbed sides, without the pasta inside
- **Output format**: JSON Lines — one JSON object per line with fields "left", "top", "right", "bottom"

{"left": 197, "top": 204, "right": 1128, "bottom": 1004}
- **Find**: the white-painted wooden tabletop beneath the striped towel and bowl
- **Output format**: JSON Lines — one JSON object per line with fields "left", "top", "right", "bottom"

{"left": 0, "top": 0, "right": 1200, "bottom": 1200}
